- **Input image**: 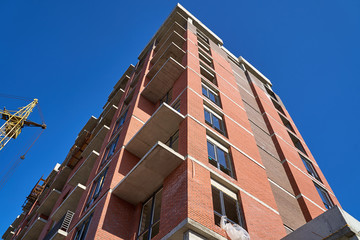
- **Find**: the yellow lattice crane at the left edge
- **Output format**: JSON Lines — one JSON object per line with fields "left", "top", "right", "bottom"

{"left": 0, "top": 99, "right": 46, "bottom": 150}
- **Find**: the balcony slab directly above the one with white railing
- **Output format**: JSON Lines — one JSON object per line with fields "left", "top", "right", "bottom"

{"left": 50, "top": 183, "right": 86, "bottom": 221}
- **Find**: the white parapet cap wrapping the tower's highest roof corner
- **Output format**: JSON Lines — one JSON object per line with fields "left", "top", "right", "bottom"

{"left": 138, "top": 3, "right": 223, "bottom": 60}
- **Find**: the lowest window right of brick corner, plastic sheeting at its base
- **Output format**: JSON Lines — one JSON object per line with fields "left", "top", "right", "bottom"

{"left": 211, "top": 180, "right": 243, "bottom": 226}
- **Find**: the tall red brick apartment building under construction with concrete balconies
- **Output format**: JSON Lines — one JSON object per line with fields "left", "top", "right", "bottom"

{"left": 3, "top": 4, "right": 354, "bottom": 240}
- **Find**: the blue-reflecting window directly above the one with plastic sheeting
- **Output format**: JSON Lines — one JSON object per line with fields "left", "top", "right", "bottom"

{"left": 207, "top": 137, "right": 234, "bottom": 177}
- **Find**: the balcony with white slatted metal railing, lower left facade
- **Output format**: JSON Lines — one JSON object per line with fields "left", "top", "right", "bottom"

{"left": 43, "top": 211, "right": 74, "bottom": 240}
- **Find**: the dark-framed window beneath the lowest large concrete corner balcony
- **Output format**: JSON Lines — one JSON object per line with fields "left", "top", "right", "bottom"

{"left": 137, "top": 189, "right": 162, "bottom": 240}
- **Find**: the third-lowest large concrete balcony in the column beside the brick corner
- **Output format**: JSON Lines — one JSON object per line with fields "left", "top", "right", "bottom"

{"left": 141, "top": 57, "right": 185, "bottom": 103}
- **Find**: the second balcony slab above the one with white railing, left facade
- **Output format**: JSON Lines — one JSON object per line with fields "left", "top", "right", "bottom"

{"left": 68, "top": 151, "right": 99, "bottom": 186}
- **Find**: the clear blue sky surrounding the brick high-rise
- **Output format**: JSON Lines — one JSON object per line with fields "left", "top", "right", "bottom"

{"left": 0, "top": 0, "right": 360, "bottom": 235}
